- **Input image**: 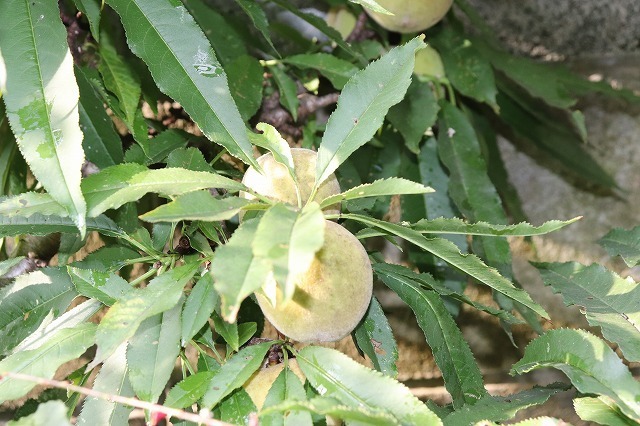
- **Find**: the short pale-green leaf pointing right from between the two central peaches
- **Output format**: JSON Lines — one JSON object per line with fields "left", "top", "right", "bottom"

{"left": 320, "top": 178, "right": 433, "bottom": 208}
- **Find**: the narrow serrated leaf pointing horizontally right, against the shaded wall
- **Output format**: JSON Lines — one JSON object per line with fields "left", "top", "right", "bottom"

{"left": 411, "top": 216, "right": 582, "bottom": 237}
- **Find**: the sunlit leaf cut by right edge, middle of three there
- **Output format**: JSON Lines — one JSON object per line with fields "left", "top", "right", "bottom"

{"left": 534, "top": 262, "right": 640, "bottom": 362}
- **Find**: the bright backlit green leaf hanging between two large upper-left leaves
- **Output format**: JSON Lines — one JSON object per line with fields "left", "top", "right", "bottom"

{"left": 98, "top": 31, "right": 142, "bottom": 129}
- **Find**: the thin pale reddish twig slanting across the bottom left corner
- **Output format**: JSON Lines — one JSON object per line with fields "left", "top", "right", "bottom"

{"left": 0, "top": 371, "right": 233, "bottom": 426}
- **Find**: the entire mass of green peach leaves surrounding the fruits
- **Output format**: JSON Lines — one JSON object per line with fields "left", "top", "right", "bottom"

{"left": 0, "top": 0, "right": 640, "bottom": 425}
